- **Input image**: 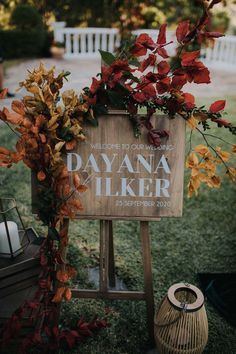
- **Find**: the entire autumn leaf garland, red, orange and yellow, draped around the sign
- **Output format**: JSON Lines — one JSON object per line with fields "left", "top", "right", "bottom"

{"left": 0, "top": 0, "right": 236, "bottom": 350}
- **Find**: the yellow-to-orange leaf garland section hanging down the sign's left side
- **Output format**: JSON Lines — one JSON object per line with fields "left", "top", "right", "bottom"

{"left": 0, "top": 68, "right": 108, "bottom": 353}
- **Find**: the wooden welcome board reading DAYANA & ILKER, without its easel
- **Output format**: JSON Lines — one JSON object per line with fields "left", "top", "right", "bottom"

{"left": 65, "top": 111, "right": 185, "bottom": 220}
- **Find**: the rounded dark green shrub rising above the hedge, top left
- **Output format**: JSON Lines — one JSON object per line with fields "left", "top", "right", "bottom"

{"left": 10, "top": 4, "right": 43, "bottom": 30}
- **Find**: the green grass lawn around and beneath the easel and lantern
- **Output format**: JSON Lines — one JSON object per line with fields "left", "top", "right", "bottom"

{"left": 0, "top": 97, "right": 236, "bottom": 354}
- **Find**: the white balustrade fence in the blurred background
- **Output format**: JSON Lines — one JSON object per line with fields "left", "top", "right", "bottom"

{"left": 53, "top": 22, "right": 236, "bottom": 72}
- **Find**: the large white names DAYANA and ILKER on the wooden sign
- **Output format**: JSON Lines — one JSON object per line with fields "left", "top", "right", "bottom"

{"left": 67, "top": 151, "right": 171, "bottom": 198}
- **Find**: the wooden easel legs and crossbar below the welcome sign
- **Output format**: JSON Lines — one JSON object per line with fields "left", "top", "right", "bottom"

{"left": 62, "top": 219, "right": 154, "bottom": 343}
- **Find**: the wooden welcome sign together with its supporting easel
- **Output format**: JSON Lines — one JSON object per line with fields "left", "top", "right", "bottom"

{"left": 31, "top": 110, "right": 185, "bottom": 340}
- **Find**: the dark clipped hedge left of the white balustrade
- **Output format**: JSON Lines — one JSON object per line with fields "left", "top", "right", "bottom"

{"left": 0, "top": 29, "right": 52, "bottom": 59}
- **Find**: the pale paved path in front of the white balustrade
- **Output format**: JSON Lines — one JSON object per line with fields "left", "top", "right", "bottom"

{"left": 1, "top": 58, "right": 236, "bottom": 111}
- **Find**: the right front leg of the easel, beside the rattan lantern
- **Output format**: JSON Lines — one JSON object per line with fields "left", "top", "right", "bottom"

{"left": 140, "top": 221, "right": 154, "bottom": 343}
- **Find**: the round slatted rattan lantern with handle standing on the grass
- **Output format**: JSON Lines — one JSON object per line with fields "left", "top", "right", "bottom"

{"left": 154, "top": 283, "right": 208, "bottom": 354}
